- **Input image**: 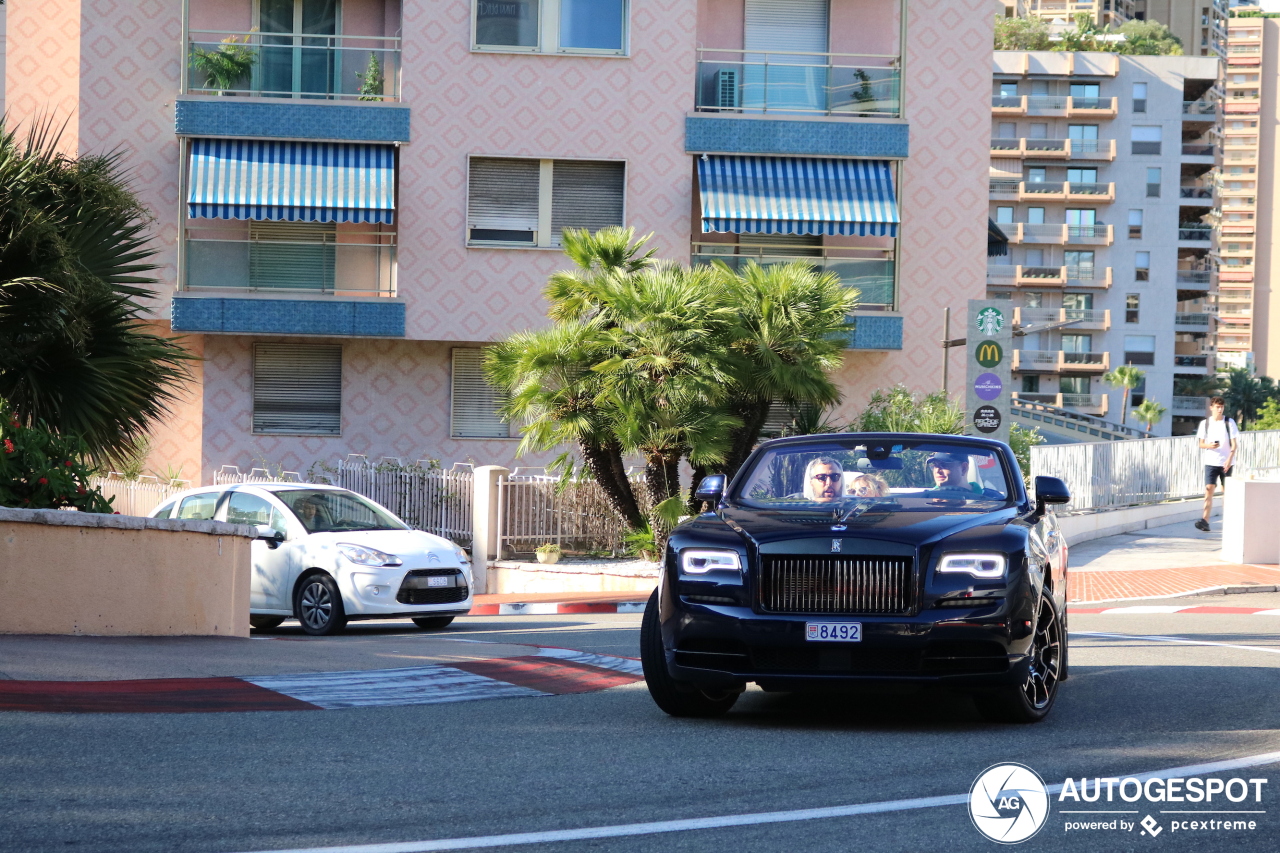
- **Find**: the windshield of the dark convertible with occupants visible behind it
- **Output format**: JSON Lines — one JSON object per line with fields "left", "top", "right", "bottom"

{"left": 730, "top": 437, "right": 1014, "bottom": 516}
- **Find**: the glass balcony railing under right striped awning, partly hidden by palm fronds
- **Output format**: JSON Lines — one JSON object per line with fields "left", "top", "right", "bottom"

{"left": 690, "top": 242, "right": 896, "bottom": 310}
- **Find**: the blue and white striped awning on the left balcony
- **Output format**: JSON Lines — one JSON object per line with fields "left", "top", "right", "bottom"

{"left": 187, "top": 140, "right": 396, "bottom": 223}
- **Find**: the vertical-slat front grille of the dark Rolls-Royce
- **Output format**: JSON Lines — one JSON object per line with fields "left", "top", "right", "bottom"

{"left": 760, "top": 555, "right": 915, "bottom": 615}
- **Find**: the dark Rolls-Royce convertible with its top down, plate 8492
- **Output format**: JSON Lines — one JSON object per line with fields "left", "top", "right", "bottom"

{"left": 640, "top": 433, "right": 1070, "bottom": 722}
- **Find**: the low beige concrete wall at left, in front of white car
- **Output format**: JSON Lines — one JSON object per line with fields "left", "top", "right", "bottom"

{"left": 0, "top": 508, "right": 253, "bottom": 637}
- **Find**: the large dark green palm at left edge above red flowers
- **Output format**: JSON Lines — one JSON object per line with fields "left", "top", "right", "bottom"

{"left": 0, "top": 123, "right": 193, "bottom": 460}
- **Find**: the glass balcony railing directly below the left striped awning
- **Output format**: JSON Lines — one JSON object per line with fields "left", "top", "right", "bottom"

{"left": 183, "top": 229, "right": 396, "bottom": 296}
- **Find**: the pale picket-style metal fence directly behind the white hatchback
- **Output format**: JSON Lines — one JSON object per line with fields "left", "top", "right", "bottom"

{"left": 214, "top": 455, "right": 474, "bottom": 547}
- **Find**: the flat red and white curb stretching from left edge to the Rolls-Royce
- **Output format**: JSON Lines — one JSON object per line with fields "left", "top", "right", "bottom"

{"left": 0, "top": 648, "right": 644, "bottom": 713}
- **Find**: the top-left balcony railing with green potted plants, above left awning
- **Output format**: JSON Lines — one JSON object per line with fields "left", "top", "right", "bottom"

{"left": 180, "top": 29, "right": 401, "bottom": 101}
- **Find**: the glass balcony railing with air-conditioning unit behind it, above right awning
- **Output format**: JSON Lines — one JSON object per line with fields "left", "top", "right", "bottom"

{"left": 695, "top": 47, "right": 901, "bottom": 118}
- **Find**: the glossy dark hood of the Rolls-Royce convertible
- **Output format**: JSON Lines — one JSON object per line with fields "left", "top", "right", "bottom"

{"left": 721, "top": 507, "right": 1018, "bottom": 546}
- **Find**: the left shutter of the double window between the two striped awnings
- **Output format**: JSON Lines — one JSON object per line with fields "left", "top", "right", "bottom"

{"left": 467, "top": 158, "right": 539, "bottom": 235}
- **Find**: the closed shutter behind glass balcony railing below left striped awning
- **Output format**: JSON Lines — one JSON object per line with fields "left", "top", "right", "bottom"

{"left": 248, "top": 220, "right": 337, "bottom": 292}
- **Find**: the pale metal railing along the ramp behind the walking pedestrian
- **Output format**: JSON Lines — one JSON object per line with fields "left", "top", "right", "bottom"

{"left": 1032, "top": 430, "right": 1280, "bottom": 511}
